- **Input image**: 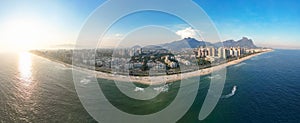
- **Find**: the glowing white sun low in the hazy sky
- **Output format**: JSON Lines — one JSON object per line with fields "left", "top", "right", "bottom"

{"left": 3, "top": 18, "right": 48, "bottom": 51}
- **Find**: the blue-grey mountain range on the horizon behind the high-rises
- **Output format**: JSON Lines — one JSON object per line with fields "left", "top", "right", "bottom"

{"left": 139, "top": 37, "right": 257, "bottom": 50}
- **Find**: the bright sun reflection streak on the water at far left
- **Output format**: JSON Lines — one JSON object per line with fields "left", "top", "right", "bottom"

{"left": 19, "top": 52, "right": 32, "bottom": 86}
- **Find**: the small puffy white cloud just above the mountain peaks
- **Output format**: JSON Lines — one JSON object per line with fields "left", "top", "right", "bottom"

{"left": 176, "top": 27, "right": 200, "bottom": 38}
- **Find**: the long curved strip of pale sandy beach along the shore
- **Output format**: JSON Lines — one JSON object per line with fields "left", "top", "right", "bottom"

{"left": 31, "top": 50, "right": 273, "bottom": 85}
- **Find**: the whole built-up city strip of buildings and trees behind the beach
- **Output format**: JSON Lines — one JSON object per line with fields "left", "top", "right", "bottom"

{"left": 32, "top": 47, "right": 262, "bottom": 73}
